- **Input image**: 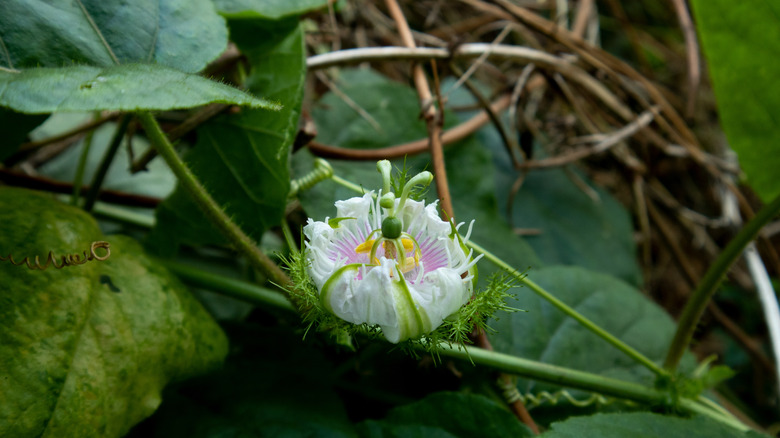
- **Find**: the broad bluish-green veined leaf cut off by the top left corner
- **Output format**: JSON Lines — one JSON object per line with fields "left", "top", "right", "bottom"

{"left": 0, "top": 0, "right": 227, "bottom": 73}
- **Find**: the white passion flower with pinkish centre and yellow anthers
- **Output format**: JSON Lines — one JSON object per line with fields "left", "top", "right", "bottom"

{"left": 303, "top": 193, "right": 476, "bottom": 343}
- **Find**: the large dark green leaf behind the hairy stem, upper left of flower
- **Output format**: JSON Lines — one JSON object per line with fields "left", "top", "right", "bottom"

{"left": 152, "top": 21, "right": 306, "bottom": 252}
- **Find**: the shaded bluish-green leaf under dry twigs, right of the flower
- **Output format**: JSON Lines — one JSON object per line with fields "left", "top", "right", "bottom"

{"left": 488, "top": 139, "right": 642, "bottom": 286}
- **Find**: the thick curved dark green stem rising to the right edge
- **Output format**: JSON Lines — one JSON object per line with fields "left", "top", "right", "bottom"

{"left": 664, "top": 196, "right": 780, "bottom": 371}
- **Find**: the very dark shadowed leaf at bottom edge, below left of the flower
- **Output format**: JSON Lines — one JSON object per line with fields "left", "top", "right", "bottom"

{"left": 130, "top": 325, "right": 356, "bottom": 438}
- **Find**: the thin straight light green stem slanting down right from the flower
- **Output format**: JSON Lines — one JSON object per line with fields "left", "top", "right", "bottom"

{"left": 466, "top": 241, "right": 669, "bottom": 376}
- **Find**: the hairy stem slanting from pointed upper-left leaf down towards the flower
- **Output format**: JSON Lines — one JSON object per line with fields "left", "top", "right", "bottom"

{"left": 138, "top": 112, "right": 290, "bottom": 287}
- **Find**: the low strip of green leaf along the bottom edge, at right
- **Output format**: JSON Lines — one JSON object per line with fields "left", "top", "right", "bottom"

{"left": 541, "top": 412, "right": 764, "bottom": 438}
